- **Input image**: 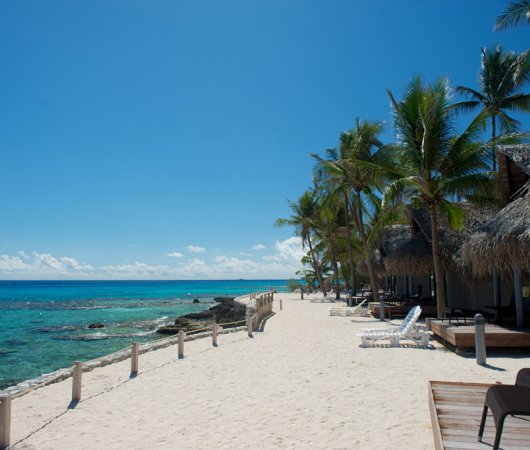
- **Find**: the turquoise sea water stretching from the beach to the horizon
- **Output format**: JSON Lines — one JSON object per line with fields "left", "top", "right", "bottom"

{"left": 0, "top": 280, "right": 287, "bottom": 389}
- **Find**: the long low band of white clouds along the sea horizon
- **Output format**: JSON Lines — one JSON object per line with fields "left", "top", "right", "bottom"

{"left": 0, "top": 238, "right": 305, "bottom": 280}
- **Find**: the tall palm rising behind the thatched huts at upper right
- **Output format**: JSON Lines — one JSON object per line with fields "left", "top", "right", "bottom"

{"left": 455, "top": 46, "right": 530, "bottom": 175}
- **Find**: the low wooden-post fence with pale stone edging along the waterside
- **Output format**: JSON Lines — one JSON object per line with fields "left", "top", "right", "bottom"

{"left": 0, "top": 291, "right": 283, "bottom": 449}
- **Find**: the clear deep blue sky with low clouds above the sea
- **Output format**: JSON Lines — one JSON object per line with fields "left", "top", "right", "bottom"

{"left": 0, "top": 0, "right": 530, "bottom": 279}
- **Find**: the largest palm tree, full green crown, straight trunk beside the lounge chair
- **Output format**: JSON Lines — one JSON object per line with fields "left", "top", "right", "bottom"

{"left": 384, "top": 77, "right": 491, "bottom": 317}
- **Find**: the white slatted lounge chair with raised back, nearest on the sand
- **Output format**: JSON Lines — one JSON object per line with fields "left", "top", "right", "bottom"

{"left": 357, "top": 306, "right": 429, "bottom": 347}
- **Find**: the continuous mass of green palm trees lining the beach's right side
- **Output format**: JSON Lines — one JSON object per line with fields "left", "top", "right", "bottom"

{"left": 276, "top": 0, "right": 530, "bottom": 319}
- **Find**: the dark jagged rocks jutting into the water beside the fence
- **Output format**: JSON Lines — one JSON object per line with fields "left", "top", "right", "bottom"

{"left": 157, "top": 297, "right": 246, "bottom": 335}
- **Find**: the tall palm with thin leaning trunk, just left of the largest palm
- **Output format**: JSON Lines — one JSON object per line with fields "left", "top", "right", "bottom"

{"left": 312, "top": 118, "right": 391, "bottom": 320}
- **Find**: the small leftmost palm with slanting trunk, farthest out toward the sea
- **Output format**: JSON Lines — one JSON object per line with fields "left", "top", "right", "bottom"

{"left": 274, "top": 190, "right": 326, "bottom": 295}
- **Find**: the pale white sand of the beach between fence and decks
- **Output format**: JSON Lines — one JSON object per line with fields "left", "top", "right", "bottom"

{"left": 7, "top": 294, "right": 530, "bottom": 450}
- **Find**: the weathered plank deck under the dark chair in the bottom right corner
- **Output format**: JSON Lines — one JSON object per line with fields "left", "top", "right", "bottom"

{"left": 429, "top": 381, "right": 530, "bottom": 450}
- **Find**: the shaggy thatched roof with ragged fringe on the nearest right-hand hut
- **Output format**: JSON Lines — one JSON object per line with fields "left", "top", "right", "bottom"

{"left": 461, "top": 184, "right": 530, "bottom": 277}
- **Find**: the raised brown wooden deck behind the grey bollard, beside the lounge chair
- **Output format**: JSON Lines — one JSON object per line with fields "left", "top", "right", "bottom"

{"left": 426, "top": 319, "right": 530, "bottom": 349}
